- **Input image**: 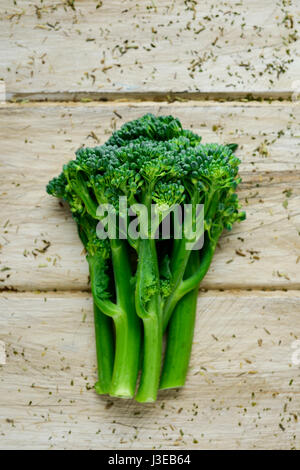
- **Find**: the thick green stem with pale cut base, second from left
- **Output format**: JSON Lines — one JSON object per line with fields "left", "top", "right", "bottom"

{"left": 110, "top": 240, "right": 141, "bottom": 398}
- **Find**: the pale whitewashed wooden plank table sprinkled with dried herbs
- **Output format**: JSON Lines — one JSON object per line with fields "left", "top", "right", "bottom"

{"left": 0, "top": 0, "right": 300, "bottom": 449}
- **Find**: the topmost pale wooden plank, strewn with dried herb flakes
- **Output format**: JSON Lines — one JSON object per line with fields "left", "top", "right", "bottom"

{"left": 0, "top": 0, "right": 300, "bottom": 99}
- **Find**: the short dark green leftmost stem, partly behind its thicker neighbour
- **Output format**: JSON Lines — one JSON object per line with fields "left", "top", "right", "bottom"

{"left": 94, "top": 302, "right": 114, "bottom": 395}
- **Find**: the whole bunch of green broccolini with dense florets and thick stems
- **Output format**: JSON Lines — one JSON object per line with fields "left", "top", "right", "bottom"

{"left": 47, "top": 114, "right": 245, "bottom": 402}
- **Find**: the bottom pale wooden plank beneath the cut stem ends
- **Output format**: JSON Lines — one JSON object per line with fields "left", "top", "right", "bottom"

{"left": 0, "top": 291, "right": 300, "bottom": 449}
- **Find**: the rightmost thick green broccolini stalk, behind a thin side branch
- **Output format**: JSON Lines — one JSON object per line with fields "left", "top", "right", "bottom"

{"left": 160, "top": 253, "right": 199, "bottom": 389}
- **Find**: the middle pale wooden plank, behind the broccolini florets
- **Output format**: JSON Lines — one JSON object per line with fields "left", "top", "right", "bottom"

{"left": 0, "top": 103, "right": 300, "bottom": 290}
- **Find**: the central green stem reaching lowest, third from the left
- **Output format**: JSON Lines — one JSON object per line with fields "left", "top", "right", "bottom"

{"left": 135, "top": 238, "right": 163, "bottom": 402}
